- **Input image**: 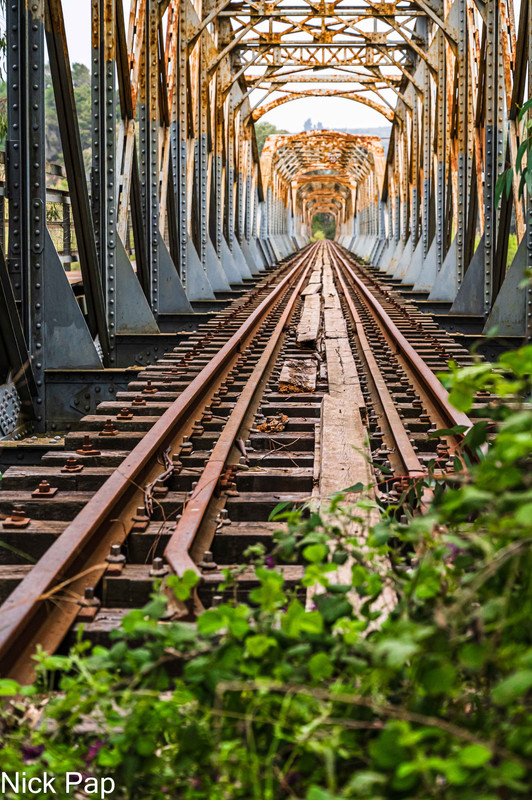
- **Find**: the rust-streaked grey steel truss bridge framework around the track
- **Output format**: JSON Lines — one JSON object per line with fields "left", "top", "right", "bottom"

{"left": 0, "top": 0, "right": 532, "bottom": 437}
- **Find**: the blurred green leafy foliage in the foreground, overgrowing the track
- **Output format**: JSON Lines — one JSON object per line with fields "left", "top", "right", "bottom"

{"left": 0, "top": 346, "right": 532, "bottom": 800}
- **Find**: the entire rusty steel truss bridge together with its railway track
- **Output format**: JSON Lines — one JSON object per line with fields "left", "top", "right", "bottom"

{"left": 0, "top": 0, "right": 532, "bottom": 682}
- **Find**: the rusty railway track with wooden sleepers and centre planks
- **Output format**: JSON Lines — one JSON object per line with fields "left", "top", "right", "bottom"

{"left": 0, "top": 242, "right": 470, "bottom": 682}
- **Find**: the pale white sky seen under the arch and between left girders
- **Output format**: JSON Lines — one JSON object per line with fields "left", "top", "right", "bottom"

{"left": 59, "top": 0, "right": 388, "bottom": 133}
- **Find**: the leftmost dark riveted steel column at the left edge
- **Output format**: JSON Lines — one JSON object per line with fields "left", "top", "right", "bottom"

{"left": 6, "top": 0, "right": 46, "bottom": 422}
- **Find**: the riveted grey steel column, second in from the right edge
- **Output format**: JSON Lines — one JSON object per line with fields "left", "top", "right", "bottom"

{"left": 484, "top": 0, "right": 503, "bottom": 314}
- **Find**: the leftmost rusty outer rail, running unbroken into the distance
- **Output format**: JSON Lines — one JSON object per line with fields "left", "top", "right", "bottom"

{"left": 0, "top": 247, "right": 315, "bottom": 683}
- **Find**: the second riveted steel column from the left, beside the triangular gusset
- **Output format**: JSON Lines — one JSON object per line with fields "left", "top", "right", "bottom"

{"left": 91, "top": 0, "right": 117, "bottom": 364}
